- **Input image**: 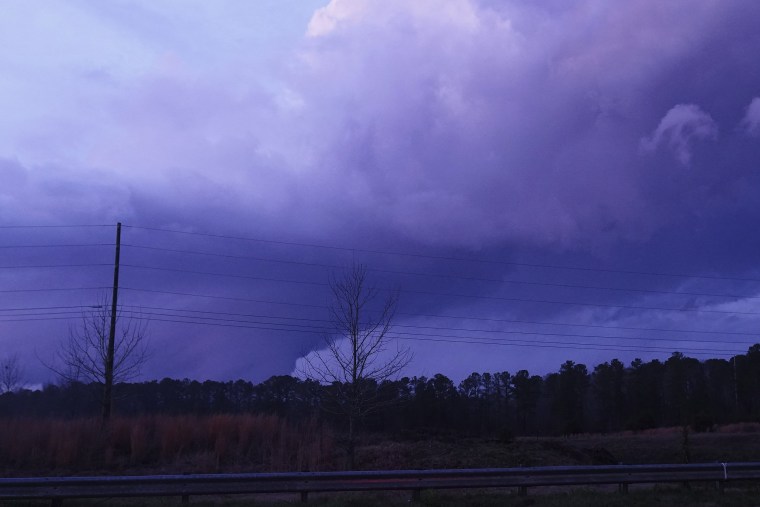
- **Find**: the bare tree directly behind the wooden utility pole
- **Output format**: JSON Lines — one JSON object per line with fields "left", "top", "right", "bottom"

{"left": 46, "top": 297, "right": 148, "bottom": 419}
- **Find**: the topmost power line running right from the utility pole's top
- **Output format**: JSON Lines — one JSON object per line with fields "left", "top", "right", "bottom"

{"left": 124, "top": 225, "right": 760, "bottom": 282}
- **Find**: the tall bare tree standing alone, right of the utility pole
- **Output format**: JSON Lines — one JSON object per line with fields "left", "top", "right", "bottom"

{"left": 302, "top": 264, "right": 412, "bottom": 468}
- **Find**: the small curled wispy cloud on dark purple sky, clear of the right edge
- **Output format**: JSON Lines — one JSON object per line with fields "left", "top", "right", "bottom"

{"left": 641, "top": 104, "right": 718, "bottom": 166}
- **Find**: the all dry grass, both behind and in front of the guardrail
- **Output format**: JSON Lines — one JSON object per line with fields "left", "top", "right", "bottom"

{"left": 0, "top": 415, "right": 760, "bottom": 507}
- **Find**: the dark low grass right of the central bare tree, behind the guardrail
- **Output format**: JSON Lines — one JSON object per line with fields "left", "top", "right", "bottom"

{"left": 357, "top": 426, "right": 760, "bottom": 470}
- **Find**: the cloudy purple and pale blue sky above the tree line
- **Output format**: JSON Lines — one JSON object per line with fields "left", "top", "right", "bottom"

{"left": 0, "top": 0, "right": 760, "bottom": 383}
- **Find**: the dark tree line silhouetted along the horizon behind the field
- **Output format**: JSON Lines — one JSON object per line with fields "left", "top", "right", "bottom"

{"left": 0, "top": 344, "right": 760, "bottom": 438}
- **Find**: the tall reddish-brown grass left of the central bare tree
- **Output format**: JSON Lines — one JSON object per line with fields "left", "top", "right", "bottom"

{"left": 0, "top": 414, "right": 335, "bottom": 475}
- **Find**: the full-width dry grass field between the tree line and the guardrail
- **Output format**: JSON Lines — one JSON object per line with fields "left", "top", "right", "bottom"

{"left": 0, "top": 415, "right": 760, "bottom": 476}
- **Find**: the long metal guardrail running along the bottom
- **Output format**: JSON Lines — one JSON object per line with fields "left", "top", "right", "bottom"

{"left": 0, "top": 462, "right": 760, "bottom": 505}
